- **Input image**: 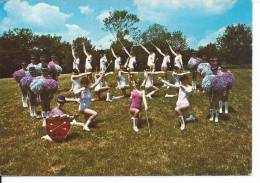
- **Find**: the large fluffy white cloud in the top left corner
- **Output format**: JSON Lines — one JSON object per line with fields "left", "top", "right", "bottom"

{"left": 0, "top": 0, "right": 71, "bottom": 31}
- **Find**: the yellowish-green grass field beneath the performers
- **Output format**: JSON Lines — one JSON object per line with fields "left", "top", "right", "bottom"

{"left": 0, "top": 69, "right": 252, "bottom": 176}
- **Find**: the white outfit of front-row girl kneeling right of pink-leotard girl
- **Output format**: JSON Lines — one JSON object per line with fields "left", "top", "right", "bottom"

{"left": 176, "top": 85, "right": 192, "bottom": 108}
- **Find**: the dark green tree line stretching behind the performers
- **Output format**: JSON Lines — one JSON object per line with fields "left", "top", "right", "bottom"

{"left": 0, "top": 10, "right": 252, "bottom": 78}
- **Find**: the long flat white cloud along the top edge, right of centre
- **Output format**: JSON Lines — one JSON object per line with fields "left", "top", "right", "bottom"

{"left": 134, "top": 0, "right": 237, "bottom": 14}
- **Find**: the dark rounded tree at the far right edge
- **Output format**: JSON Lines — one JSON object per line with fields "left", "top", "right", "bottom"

{"left": 217, "top": 24, "right": 252, "bottom": 64}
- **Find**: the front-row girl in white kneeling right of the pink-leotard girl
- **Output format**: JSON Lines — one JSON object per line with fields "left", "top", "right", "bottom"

{"left": 161, "top": 75, "right": 195, "bottom": 130}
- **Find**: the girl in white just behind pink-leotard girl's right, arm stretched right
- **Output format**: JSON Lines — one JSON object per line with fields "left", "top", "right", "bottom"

{"left": 141, "top": 68, "right": 163, "bottom": 99}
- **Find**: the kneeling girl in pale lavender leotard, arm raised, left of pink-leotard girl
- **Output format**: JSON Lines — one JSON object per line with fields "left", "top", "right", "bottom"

{"left": 72, "top": 74, "right": 104, "bottom": 131}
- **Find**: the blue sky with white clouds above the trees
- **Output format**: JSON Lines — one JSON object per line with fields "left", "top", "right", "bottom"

{"left": 0, "top": 0, "right": 252, "bottom": 49}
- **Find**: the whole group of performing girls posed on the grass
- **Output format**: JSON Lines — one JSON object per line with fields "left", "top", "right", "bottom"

{"left": 13, "top": 43, "right": 234, "bottom": 140}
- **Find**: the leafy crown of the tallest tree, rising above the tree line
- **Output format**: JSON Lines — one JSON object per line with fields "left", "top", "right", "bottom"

{"left": 103, "top": 10, "right": 139, "bottom": 40}
